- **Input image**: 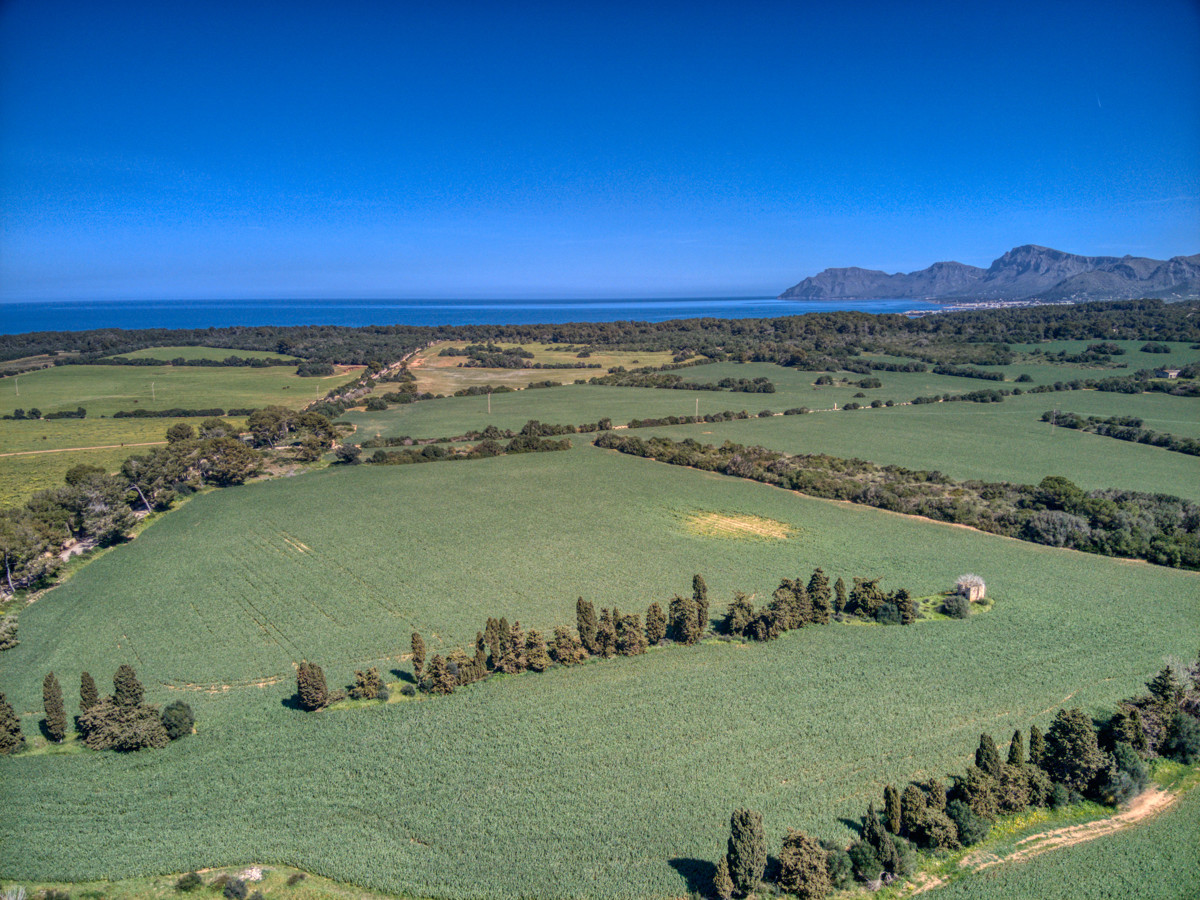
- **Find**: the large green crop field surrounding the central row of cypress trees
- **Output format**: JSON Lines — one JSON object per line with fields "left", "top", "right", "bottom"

{"left": 0, "top": 442, "right": 1200, "bottom": 898}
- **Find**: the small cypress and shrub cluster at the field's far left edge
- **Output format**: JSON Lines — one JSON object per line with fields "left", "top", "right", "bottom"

{"left": 0, "top": 665, "right": 196, "bottom": 756}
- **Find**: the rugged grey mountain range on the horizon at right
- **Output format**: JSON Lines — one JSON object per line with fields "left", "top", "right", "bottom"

{"left": 779, "top": 244, "right": 1200, "bottom": 302}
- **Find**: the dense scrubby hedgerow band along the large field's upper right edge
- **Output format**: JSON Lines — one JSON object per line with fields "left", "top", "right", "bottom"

{"left": 595, "top": 432, "right": 1200, "bottom": 569}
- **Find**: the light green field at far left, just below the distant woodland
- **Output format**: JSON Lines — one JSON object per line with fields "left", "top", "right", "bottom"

{"left": 0, "top": 366, "right": 360, "bottom": 418}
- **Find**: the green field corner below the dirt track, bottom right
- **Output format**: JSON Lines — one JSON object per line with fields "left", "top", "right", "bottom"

{"left": 929, "top": 790, "right": 1200, "bottom": 900}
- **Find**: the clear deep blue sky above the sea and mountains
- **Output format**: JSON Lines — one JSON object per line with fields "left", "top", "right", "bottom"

{"left": 0, "top": 0, "right": 1200, "bottom": 300}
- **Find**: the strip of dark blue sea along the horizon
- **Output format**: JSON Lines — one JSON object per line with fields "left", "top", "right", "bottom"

{"left": 0, "top": 296, "right": 940, "bottom": 335}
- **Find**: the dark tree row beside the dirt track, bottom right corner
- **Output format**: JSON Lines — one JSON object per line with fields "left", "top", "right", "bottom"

{"left": 713, "top": 660, "right": 1200, "bottom": 900}
